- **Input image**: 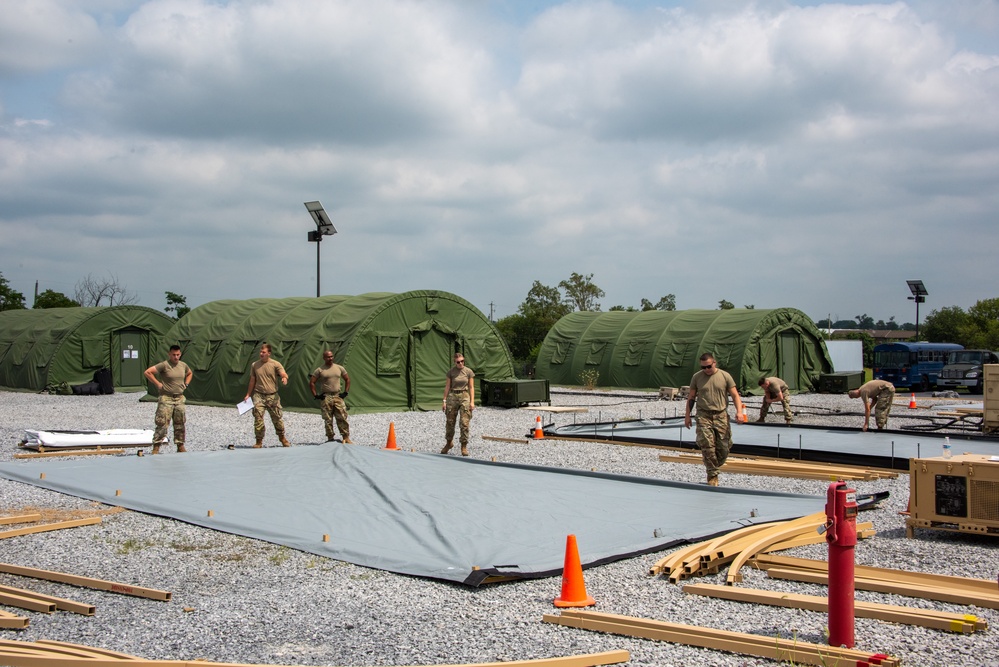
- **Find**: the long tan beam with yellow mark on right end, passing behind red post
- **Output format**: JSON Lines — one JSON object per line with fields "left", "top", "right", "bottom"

{"left": 683, "top": 584, "right": 988, "bottom": 634}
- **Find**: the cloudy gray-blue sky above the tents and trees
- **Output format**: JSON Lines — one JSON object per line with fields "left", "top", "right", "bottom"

{"left": 0, "top": 0, "right": 999, "bottom": 323}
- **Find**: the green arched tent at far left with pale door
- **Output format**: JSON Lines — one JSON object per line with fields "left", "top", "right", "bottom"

{"left": 0, "top": 306, "right": 174, "bottom": 391}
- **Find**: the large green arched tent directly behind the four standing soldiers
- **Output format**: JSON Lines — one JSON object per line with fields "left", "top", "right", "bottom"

{"left": 160, "top": 291, "right": 514, "bottom": 413}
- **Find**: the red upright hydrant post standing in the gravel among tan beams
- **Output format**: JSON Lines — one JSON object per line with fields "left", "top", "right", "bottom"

{"left": 825, "top": 482, "right": 857, "bottom": 648}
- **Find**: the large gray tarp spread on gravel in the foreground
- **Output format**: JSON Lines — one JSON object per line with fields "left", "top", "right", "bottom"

{"left": 0, "top": 443, "right": 824, "bottom": 585}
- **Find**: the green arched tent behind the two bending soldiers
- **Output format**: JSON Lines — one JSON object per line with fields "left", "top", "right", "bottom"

{"left": 537, "top": 308, "right": 832, "bottom": 394}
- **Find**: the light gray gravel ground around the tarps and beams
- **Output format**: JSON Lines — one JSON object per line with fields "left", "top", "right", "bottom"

{"left": 0, "top": 392, "right": 999, "bottom": 667}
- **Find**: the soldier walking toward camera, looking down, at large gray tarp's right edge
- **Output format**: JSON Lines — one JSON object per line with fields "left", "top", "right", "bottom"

{"left": 683, "top": 353, "right": 746, "bottom": 486}
